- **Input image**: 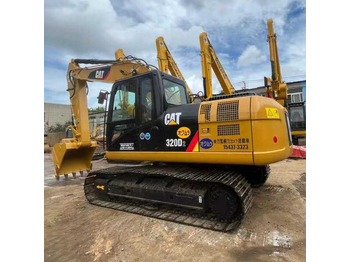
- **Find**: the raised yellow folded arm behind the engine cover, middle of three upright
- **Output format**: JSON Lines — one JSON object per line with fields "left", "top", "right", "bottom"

{"left": 199, "top": 32, "right": 235, "bottom": 99}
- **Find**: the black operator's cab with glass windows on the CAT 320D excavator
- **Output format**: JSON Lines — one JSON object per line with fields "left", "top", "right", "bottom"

{"left": 107, "top": 70, "right": 193, "bottom": 154}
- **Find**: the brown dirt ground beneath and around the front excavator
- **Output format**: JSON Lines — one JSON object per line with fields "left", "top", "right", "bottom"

{"left": 44, "top": 154, "right": 306, "bottom": 262}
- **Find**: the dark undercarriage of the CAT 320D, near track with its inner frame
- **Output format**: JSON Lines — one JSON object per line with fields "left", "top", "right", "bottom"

{"left": 84, "top": 165, "right": 269, "bottom": 232}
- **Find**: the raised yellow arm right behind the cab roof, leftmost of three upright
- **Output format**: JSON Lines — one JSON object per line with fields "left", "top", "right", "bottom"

{"left": 156, "top": 36, "right": 192, "bottom": 97}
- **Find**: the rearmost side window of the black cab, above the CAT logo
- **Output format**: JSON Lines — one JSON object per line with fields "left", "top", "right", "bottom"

{"left": 163, "top": 79, "right": 188, "bottom": 105}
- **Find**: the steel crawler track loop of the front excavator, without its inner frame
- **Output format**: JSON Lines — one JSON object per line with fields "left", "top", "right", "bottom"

{"left": 84, "top": 166, "right": 253, "bottom": 232}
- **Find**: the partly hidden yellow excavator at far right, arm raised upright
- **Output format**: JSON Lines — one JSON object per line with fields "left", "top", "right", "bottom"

{"left": 264, "top": 19, "right": 306, "bottom": 145}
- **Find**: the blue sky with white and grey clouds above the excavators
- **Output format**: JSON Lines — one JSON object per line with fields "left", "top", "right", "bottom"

{"left": 44, "top": 0, "right": 306, "bottom": 107}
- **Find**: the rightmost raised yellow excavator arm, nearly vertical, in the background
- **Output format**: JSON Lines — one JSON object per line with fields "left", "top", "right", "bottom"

{"left": 264, "top": 19, "right": 288, "bottom": 106}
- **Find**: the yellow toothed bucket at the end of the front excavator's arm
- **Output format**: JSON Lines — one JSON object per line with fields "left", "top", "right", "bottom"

{"left": 52, "top": 139, "right": 97, "bottom": 179}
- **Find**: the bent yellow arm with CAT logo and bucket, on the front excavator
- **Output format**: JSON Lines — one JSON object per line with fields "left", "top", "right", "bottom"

{"left": 52, "top": 49, "right": 153, "bottom": 179}
